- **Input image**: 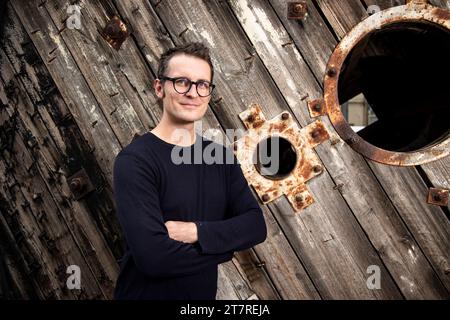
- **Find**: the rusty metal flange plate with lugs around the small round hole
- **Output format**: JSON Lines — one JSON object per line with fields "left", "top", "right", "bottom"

{"left": 233, "top": 104, "right": 330, "bottom": 212}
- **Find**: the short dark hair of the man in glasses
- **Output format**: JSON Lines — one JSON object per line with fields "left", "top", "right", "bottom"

{"left": 157, "top": 42, "right": 214, "bottom": 82}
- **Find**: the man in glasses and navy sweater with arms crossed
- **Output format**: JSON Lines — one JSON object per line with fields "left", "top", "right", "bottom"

{"left": 113, "top": 43, "right": 267, "bottom": 299}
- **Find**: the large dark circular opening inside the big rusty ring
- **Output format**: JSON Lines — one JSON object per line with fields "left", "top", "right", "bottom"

{"left": 338, "top": 22, "right": 450, "bottom": 152}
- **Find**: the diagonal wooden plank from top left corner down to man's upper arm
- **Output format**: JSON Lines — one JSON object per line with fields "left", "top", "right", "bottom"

{"left": 11, "top": 1, "right": 121, "bottom": 185}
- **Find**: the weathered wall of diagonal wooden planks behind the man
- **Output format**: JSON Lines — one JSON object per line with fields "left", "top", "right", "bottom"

{"left": 0, "top": 0, "right": 450, "bottom": 299}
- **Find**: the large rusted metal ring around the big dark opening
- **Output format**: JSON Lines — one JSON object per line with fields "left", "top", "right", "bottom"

{"left": 324, "top": 2, "right": 450, "bottom": 166}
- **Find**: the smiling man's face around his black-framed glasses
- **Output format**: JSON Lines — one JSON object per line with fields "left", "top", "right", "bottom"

{"left": 154, "top": 54, "right": 211, "bottom": 124}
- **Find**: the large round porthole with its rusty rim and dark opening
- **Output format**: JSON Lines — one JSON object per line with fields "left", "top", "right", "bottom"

{"left": 324, "top": 2, "right": 450, "bottom": 166}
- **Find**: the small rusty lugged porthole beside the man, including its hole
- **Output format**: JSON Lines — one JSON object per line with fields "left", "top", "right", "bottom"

{"left": 233, "top": 103, "right": 330, "bottom": 213}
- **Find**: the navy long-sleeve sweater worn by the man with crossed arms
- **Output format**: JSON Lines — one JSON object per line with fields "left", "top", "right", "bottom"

{"left": 113, "top": 132, "right": 267, "bottom": 300}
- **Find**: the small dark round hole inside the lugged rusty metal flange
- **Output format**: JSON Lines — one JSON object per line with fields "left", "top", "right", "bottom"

{"left": 253, "top": 136, "right": 297, "bottom": 180}
